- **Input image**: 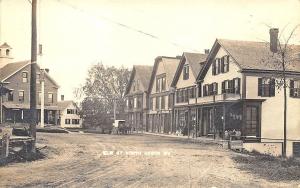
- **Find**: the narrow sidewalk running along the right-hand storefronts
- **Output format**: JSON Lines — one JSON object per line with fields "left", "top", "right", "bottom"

{"left": 143, "top": 132, "right": 228, "bottom": 146}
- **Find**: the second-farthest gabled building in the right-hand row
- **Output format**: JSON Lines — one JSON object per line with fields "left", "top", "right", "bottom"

{"left": 148, "top": 56, "right": 181, "bottom": 134}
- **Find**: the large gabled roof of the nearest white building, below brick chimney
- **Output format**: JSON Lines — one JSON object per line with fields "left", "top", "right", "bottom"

{"left": 197, "top": 39, "right": 300, "bottom": 80}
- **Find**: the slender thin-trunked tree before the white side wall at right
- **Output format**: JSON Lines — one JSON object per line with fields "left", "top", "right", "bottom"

{"left": 264, "top": 25, "right": 299, "bottom": 157}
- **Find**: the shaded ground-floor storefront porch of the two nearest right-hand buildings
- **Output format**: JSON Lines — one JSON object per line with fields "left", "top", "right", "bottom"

{"left": 173, "top": 100, "right": 263, "bottom": 142}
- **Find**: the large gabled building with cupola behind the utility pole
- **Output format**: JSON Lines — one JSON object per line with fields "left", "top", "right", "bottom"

{"left": 0, "top": 43, "right": 59, "bottom": 125}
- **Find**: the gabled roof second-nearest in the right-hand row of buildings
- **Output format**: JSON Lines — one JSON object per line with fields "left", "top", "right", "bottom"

{"left": 171, "top": 52, "right": 207, "bottom": 87}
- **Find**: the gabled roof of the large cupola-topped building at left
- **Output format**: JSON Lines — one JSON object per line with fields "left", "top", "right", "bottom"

{"left": 0, "top": 60, "right": 59, "bottom": 87}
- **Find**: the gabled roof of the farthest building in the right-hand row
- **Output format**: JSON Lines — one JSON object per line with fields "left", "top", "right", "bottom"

{"left": 125, "top": 65, "right": 153, "bottom": 95}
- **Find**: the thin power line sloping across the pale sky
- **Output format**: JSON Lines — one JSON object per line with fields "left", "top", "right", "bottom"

{"left": 57, "top": 0, "right": 199, "bottom": 52}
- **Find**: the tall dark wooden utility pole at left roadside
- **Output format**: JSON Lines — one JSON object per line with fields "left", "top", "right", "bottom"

{"left": 30, "top": 0, "right": 37, "bottom": 147}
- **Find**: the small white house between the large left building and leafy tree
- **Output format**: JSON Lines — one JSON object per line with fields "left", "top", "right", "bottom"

{"left": 57, "top": 97, "right": 82, "bottom": 128}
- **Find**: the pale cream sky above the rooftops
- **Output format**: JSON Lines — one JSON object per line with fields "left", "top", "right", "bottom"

{"left": 0, "top": 0, "right": 300, "bottom": 100}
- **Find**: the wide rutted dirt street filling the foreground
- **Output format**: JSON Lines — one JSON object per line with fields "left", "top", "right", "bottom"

{"left": 0, "top": 133, "right": 299, "bottom": 187}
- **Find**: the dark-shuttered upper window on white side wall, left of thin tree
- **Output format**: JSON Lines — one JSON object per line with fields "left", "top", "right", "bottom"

{"left": 258, "top": 78, "right": 275, "bottom": 97}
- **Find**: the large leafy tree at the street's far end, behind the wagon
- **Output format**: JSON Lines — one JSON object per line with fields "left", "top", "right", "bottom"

{"left": 74, "top": 63, "right": 130, "bottom": 127}
